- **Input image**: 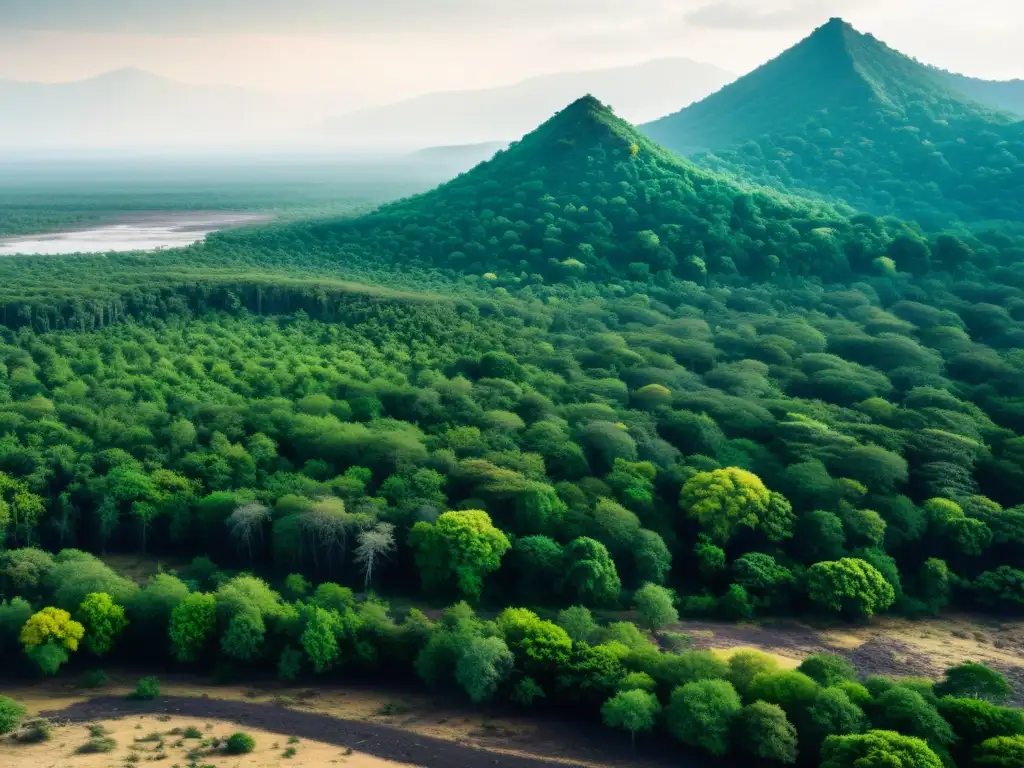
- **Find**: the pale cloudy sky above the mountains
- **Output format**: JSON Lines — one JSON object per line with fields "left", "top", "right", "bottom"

{"left": 0, "top": 0, "right": 1024, "bottom": 105}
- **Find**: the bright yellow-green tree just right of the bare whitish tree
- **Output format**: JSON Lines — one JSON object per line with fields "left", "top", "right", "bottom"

{"left": 409, "top": 510, "right": 511, "bottom": 599}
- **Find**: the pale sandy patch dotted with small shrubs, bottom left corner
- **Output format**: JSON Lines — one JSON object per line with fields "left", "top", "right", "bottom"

{"left": 0, "top": 716, "right": 399, "bottom": 768}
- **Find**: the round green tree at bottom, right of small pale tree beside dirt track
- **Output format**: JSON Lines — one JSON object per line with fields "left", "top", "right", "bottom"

{"left": 665, "top": 680, "right": 742, "bottom": 757}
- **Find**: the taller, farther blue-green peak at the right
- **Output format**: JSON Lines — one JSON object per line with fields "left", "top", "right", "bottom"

{"left": 643, "top": 18, "right": 1024, "bottom": 228}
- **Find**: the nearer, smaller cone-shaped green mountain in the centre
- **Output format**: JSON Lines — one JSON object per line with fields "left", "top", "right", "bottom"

{"left": 310, "top": 96, "right": 917, "bottom": 281}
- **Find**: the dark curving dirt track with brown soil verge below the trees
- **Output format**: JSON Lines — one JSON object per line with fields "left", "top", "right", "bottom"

{"left": 0, "top": 672, "right": 692, "bottom": 768}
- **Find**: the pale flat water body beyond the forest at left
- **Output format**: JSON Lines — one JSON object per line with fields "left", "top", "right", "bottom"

{"left": 0, "top": 212, "right": 269, "bottom": 256}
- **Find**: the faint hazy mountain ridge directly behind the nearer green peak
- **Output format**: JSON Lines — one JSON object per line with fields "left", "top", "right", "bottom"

{"left": 324, "top": 58, "right": 734, "bottom": 148}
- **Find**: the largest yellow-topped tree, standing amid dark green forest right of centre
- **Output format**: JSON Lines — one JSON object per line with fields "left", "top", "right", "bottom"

{"left": 679, "top": 467, "right": 793, "bottom": 542}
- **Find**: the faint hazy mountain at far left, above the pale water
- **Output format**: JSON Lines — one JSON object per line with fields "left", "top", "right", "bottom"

{"left": 0, "top": 69, "right": 309, "bottom": 148}
